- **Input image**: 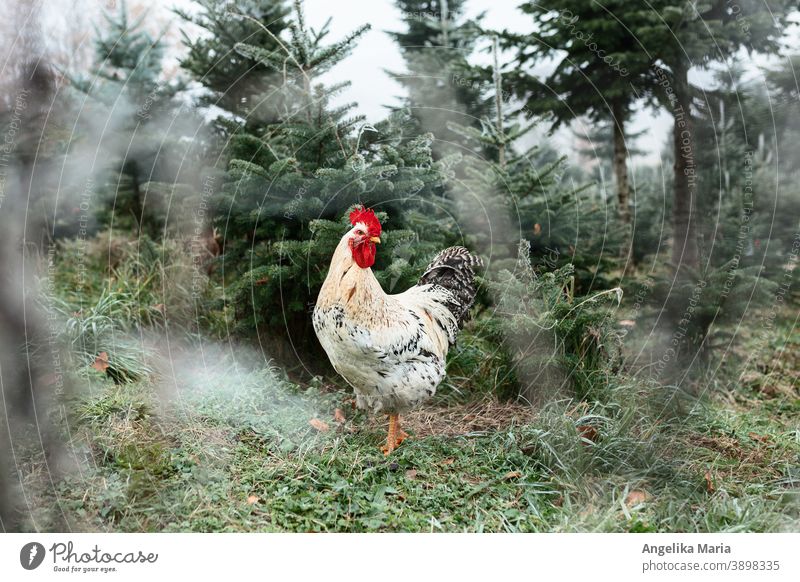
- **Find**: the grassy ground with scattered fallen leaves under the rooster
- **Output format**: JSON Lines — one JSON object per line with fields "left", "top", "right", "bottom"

{"left": 14, "top": 318, "right": 800, "bottom": 532}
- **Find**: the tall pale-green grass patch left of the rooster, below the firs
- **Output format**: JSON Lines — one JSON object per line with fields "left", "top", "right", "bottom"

{"left": 43, "top": 234, "right": 225, "bottom": 382}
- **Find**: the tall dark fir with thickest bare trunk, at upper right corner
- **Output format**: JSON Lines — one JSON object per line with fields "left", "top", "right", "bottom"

{"left": 632, "top": 0, "right": 792, "bottom": 274}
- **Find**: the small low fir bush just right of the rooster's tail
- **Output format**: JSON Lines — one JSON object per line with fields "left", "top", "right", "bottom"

{"left": 483, "top": 241, "right": 622, "bottom": 404}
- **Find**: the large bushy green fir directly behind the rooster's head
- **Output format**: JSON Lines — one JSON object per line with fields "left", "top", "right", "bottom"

{"left": 213, "top": 2, "right": 455, "bottom": 356}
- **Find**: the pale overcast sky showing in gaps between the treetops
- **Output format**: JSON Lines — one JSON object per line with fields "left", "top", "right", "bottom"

{"left": 45, "top": 0, "right": 800, "bottom": 163}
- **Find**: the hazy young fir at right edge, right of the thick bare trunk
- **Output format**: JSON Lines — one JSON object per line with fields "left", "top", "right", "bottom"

{"left": 640, "top": 64, "right": 798, "bottom": 370}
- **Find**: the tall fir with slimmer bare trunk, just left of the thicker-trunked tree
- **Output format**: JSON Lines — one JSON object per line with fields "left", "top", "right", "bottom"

{"left": 503, "top": 0, "right": 651, "bottom": 233}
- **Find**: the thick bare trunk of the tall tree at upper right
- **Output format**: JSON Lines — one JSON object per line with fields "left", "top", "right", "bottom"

{"left": 672, "top": 63, "right": 698, "bottom": 271}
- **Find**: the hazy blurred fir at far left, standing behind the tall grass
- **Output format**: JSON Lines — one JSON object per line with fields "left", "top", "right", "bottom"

{"left": 65, "top": 1, "right": 188, "bottom": 237}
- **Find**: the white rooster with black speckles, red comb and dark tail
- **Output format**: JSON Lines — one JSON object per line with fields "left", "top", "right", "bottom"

{"left": 313, "top": 207, "right": 482, "bottom": 455}
